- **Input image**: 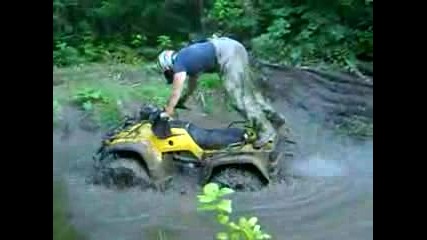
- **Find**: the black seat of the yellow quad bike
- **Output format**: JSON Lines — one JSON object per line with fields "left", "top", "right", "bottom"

{"left": 171, "top": 121, "right": 245, "bottom": 150}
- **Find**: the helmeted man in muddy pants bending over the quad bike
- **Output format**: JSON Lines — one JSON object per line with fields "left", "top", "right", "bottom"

{"left": 158, "top": 37, "right": 284, "bottom": 148}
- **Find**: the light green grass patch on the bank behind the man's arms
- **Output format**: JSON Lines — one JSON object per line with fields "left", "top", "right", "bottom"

{"left": 53, "top": 63, "right": 222, "bottom": 127}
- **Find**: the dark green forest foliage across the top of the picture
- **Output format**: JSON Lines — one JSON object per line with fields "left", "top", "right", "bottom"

{"left": 53, "top": 0, "right": 373, "bottom": 67}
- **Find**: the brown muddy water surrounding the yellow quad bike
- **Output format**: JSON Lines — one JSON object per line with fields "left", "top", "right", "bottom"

{"left": 53, "top": 67, "right": 373, "bottom": 240}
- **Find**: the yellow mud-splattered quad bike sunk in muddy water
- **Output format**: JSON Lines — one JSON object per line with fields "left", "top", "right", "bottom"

{"left": 94, "top": 105, "right": 296, "bottom": 191}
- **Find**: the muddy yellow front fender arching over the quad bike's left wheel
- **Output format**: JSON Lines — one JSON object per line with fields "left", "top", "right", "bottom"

{"left": 105, "top": 142, "right": 172, "bottom": 185}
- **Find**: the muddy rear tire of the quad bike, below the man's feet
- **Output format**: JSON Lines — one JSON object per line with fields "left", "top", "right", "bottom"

{"left": 209, "top": 165, "right": 266, "bottom": 192}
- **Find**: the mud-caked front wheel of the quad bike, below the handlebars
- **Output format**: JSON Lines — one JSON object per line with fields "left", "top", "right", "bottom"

{"left": 94, "top": 155, "right": 151, "bottom": 188}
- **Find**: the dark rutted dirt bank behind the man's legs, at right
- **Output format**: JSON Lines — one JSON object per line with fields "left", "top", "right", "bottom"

{"left": 261, "top": 62, "right": 373, "bottom": 130}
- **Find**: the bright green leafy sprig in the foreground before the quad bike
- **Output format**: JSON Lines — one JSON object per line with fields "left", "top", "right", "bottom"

{"left": 197, "top": 183, "right": 271, "bottom": 240}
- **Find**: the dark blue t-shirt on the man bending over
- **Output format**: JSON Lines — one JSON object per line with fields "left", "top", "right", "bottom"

{"left": 173, "top": 41, "right": 216, "bottom": 76}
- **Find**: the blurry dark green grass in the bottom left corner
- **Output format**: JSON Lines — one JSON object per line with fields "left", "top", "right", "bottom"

{"left": 53, "top": 184, "right": 85, "bottom": 240}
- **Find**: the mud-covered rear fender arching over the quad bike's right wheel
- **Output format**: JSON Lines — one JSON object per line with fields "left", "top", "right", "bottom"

{"left": 202, "top": 153, "right": 270, "bottom": 183}
